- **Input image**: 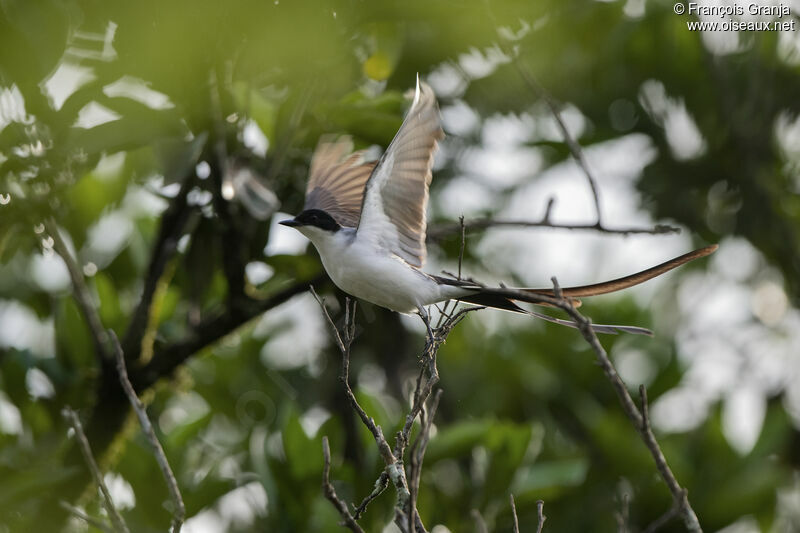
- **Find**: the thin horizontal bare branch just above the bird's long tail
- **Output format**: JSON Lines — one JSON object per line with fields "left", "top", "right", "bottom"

{"left": 427, "top": 217, "right": 681, "bottom": 241}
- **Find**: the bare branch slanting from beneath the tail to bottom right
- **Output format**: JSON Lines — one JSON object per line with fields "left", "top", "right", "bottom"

{"left": 553, "top": 277, "right": 702, "bottom": 532}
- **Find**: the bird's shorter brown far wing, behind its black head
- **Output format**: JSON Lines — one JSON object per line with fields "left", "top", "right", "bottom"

{"left": 303, "top": 136, "right": 375, "bottom": 228}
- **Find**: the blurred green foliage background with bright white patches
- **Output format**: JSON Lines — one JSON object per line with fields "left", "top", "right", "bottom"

{"left": 0, "top": 0, "right": 800, "bottom": 532}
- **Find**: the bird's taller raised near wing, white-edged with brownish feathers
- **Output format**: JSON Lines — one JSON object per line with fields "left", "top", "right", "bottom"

{"left": 358, "top": 76, "right": 444, "bottom": 267}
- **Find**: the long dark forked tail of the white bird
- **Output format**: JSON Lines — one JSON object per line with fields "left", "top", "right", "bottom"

{"left": 436, "top": 244, "right": 718, "bottom": 335}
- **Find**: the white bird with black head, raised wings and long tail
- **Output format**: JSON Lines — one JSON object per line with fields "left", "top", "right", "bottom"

{"left": 279, "top": 75, "right": 717, "bottom": 338}
